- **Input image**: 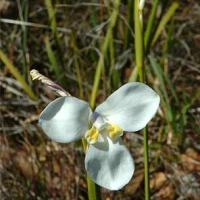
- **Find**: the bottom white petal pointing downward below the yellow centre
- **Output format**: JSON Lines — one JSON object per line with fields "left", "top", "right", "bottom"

{"left": 85, "top": 137, "right": 134, "bottom": 190}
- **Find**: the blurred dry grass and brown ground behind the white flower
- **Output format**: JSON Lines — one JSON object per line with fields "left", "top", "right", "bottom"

{"left": 0, "top": 0, "right": 200, "bottom": 200}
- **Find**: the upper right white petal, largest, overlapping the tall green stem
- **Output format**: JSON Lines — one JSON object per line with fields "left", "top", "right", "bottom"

{"left": 95, "top": 82, "right": 160, "bottom": 131}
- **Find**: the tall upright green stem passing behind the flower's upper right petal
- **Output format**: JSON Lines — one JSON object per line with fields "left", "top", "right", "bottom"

{"left": 134, "top": 0, "right": 149, "bottom": 200}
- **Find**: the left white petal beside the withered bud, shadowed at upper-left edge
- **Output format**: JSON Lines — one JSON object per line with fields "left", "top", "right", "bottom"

{"left": 39, "top": 97, "right": 91, "bottom": 143}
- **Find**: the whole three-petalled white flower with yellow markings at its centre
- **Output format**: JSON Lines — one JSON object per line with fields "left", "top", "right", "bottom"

{"left": 39, "top": 82, "right": 160, "bottom": 190}
